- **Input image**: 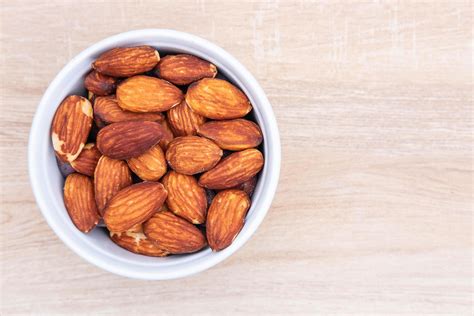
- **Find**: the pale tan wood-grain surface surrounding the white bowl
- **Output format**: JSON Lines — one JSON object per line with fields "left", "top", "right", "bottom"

{"left": 0, "top": 0, "right": 473, "bottom": 315}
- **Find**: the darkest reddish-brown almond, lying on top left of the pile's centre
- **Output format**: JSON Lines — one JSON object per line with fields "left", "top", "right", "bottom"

{"left": 97, "top": 121, "right": 163, "bottom": 160}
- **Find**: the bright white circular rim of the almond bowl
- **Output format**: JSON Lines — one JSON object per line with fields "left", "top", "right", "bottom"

{"left": 28, "top": 29, "right": 281, "bottom": 280}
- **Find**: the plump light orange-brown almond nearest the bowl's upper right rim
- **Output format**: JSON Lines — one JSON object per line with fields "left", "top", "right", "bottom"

{"left": 186, "top": 78, "right": 252, "bottom": 120}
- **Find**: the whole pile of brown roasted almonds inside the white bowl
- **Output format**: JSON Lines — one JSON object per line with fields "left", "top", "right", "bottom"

{"left": 51, "top": 46, "right": 264, "bottom": 256}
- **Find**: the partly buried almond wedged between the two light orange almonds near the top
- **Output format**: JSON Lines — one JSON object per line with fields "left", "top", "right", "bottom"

{"left": 167, "top": 100, "right": 206, "bottom": 136}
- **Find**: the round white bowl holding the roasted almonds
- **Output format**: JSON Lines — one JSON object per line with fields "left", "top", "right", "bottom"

{"left": 28, "top": 29, "right": 281, "bottom": 280}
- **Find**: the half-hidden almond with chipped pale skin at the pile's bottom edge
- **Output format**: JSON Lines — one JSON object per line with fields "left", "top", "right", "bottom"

{"left": 110, "top": 224, "right": 169, "bottom": 257}
